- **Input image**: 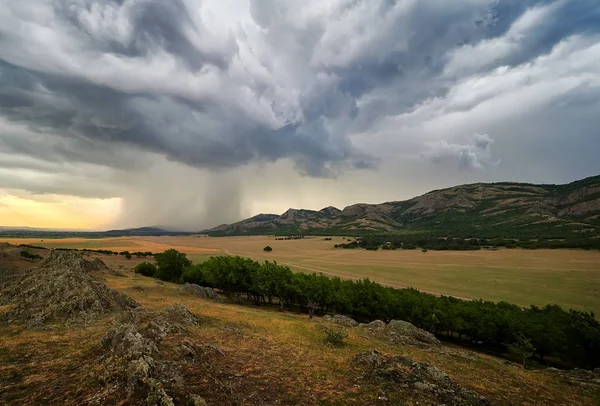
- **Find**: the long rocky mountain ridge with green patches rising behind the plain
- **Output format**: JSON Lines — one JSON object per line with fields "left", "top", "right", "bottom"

{"left": 206, "top": 176, "right": 600, "bottom": 237}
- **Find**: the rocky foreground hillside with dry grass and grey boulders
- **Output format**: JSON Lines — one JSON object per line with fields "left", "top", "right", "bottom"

{"left": 0, "top": 247, "right": 598, "bottom": 406}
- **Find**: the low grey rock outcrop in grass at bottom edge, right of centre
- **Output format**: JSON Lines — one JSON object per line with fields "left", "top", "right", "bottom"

{"left": 352, "top": 350, "right": 489, "bottom": 406}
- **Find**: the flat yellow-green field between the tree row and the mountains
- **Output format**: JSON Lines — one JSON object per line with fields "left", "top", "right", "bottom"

{"left": 5, "top": 236, "right": 600, "bottom": 314}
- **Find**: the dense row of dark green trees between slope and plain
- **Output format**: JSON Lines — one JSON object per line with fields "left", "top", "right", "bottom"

{"left": 136, "top": 249, "right": 600, "bottom": 367}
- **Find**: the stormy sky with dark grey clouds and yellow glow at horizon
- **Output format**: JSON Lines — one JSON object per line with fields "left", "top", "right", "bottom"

{"left": 0, "top": 0, "right": 600, "bottom": 230}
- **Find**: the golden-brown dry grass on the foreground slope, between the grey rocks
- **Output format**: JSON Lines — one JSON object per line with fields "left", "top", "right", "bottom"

{"left": 0, "top": 258, "right": 598, "bottom": 405}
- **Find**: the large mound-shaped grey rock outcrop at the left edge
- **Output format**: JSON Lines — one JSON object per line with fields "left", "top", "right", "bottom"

{"left": 0, "top": 251, "right": 138, "bottom": 326}
